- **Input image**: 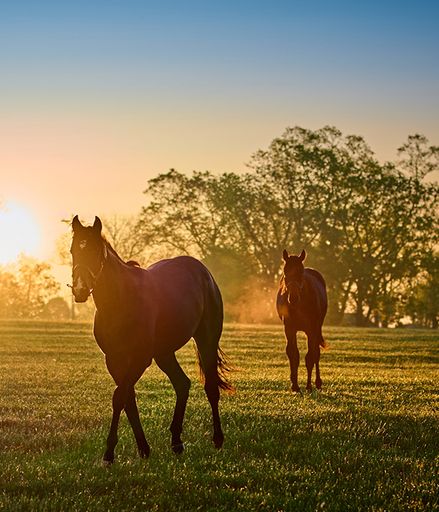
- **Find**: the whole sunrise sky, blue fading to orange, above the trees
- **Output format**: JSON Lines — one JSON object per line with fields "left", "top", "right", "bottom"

{"left": 0, "top": 0, "right": 439, "bottom": 258}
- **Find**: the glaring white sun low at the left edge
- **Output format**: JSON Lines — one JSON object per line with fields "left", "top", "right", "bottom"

{"left": 0, "top": 202, "right": 40, "bottom": 265}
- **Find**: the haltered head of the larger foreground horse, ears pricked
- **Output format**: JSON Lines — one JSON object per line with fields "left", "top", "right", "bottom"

{"left": 70, "top": 215, "right": 107, "bottom": 302}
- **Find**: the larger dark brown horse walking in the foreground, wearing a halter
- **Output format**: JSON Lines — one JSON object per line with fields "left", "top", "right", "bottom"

{"left": 71, "top": 216, "right": 231, "bottom": 463}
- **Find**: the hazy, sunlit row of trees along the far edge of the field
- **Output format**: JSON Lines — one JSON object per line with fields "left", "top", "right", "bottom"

{"left": 0, "top": 126, "right": 439, "bottom": 328}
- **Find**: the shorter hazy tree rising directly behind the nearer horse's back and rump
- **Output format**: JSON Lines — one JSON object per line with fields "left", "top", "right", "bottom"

{"left": 139, "top": 169, "right": 268, "bottom": 318}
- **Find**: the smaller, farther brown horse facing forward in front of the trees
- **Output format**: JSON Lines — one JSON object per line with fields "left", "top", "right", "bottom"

{"left": 276, "top": 250, "right": 328, "bottom": 393}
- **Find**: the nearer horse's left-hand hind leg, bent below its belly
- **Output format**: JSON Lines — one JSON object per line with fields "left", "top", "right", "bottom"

{"left": 155, "top": 353, "right": 191, "bottom": 453}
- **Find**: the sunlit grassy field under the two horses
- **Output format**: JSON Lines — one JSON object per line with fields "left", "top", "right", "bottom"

{"left": 0, "top": 322, "right": 439, "bottom": 512}
